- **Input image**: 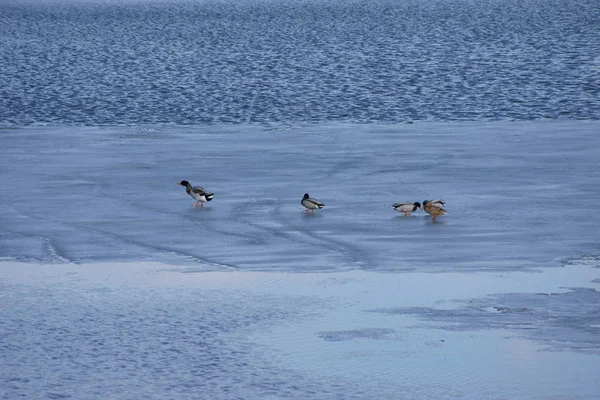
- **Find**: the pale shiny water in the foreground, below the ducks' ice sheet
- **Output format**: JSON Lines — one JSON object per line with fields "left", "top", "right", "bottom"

{"left": 0, "top": 258, "right": 600, "bottom": 400}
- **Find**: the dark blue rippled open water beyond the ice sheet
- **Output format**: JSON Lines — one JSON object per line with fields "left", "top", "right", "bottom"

{"left": 0, "top": 0, "right": 600, "bottom": 127}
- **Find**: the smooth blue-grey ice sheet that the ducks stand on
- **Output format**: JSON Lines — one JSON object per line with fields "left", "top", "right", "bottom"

{"left": 0, "top": 121, "right": 600, "bottom": 272}
